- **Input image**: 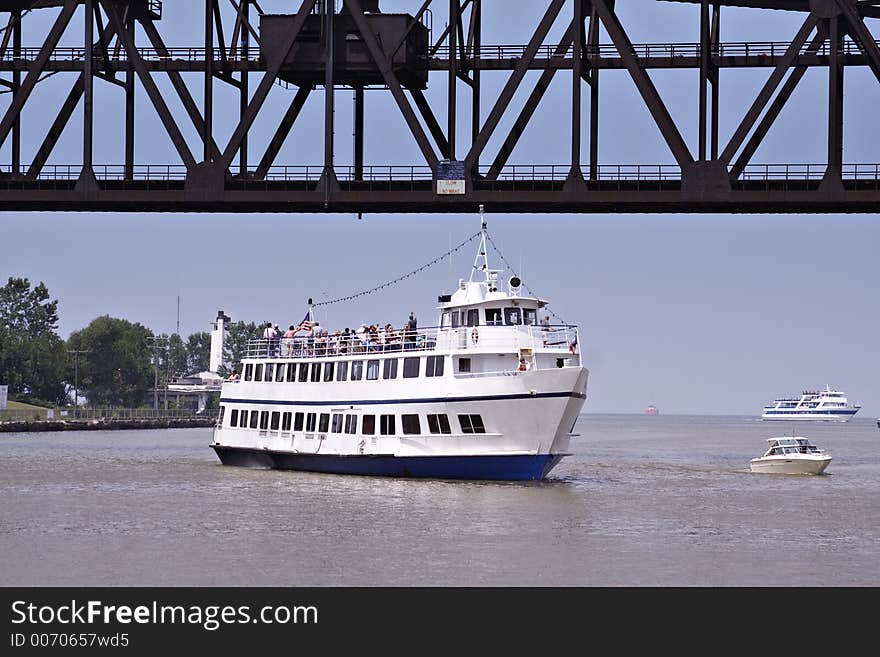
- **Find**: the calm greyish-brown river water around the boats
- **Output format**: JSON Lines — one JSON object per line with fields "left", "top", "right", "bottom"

{"left": 0, "top": 414, "right": 880, "bottom": 586}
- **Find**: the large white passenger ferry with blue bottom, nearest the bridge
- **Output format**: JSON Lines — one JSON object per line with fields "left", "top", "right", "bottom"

{"left": 211, "top": 213, "right": 588, "bottom": 480}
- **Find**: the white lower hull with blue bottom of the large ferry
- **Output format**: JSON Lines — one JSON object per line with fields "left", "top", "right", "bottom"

{"left": 211, "top": 367, "right": 588, "bottom": 480}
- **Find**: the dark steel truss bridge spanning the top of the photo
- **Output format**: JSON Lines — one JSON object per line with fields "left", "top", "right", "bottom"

{"left": 0, "top": 0, "right": 880, "bottom": 213}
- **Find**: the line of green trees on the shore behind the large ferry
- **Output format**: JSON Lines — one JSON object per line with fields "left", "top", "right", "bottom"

{"left": 0, "top": 277, "right": 265, "bottom": 407}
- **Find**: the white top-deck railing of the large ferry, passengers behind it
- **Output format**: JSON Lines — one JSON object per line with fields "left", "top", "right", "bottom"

{"left": 245, "top": 324, "right": 578, "bottom": 359}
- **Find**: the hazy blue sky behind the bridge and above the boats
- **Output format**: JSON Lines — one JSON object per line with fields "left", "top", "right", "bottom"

{"left": 0, "top": 0, "right": 880, "bottom": 417}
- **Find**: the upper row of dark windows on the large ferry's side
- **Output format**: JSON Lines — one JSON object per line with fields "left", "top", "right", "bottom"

{"left": 243, "top": 356, "right": 444, "bottom": 383}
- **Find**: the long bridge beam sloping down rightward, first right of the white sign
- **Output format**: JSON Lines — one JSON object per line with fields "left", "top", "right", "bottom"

{"left": 593, "top": 0, "right": 694, "bottom": 169}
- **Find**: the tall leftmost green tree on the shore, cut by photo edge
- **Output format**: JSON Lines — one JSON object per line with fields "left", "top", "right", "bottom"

{"left": 0, "top": 277, "right": 67, "bottom": 403}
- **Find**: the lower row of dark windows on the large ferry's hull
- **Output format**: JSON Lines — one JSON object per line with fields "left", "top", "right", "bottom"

{"left": 219, "top": 406, "right": 486, "bottom": 436}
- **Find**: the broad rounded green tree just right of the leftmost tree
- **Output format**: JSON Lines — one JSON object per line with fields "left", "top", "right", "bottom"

{"left": 67, "top": 315, "right": 154, "bottom": 406}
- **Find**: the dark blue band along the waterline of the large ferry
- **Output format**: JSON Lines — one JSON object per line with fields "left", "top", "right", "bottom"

{"left": 212, "top": 445, "right": 565, "bottom": 481}
